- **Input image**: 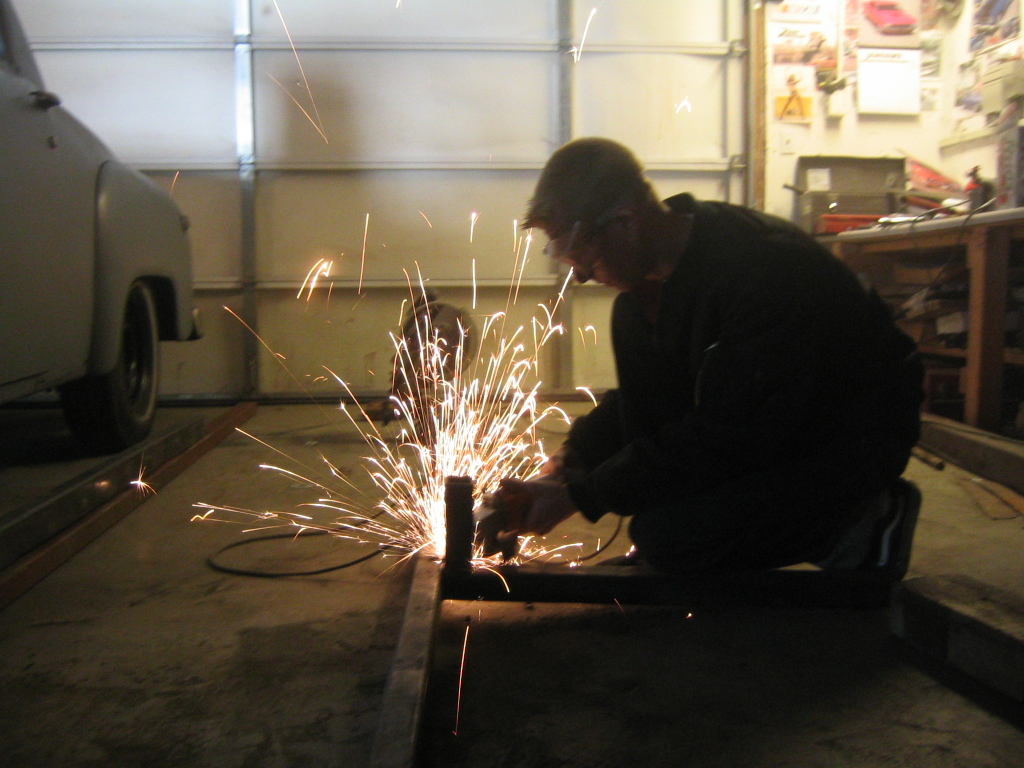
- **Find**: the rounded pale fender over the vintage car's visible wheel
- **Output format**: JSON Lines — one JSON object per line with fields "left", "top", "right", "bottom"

{"left": 89, "top": 160, "right": 195, "bottom": 376}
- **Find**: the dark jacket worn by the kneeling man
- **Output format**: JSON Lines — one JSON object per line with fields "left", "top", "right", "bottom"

{"left": 566, "top": 195, "right": 921, "bottom": 520}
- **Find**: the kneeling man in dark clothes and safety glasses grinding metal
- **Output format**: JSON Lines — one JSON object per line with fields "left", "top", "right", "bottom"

{"left": 499, "top": 138, "right": 924, "bottom": 580}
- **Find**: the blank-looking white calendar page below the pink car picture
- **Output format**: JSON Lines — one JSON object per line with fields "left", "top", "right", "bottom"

{"left": 857, "top": 48, "right": 921, "bottom": 115}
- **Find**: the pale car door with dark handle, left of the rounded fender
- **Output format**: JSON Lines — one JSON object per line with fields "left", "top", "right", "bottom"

{"left": 0, "top": 0, "right": 95, "bottom": 400}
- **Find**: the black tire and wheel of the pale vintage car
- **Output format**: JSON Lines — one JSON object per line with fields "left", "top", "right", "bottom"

{"left": 59, "top": 283, "right": 160, "bottom": 453}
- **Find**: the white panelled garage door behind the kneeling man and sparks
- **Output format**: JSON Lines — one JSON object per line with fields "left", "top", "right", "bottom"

{"left": 14, "top": 0, "right": 749, "bottom": 396}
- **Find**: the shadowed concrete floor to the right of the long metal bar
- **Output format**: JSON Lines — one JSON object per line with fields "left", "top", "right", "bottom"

{"left": 420, "top": 450, "right": 1024, "bottom": 768}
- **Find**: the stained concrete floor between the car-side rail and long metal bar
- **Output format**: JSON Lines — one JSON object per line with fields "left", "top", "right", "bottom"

{"left": 0, "top": 407, "right": 410, "bottom": 768}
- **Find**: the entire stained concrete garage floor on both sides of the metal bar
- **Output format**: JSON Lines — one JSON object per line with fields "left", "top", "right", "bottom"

{"left": 0, "top": 407, "right": 1024, "bottom": 768}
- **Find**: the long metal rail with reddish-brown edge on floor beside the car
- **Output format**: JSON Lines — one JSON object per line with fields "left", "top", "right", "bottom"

{"left": 0, "top": 402, "right": 256, "bottom": 609}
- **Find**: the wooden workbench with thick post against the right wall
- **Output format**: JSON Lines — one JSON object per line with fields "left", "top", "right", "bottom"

{"left": 831, "top": 208, "right": 1024, "bottom": 431}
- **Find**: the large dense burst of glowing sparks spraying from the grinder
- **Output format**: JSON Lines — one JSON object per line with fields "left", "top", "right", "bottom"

{"left": 194, "top": 266, "right": 580, "bottom": 569}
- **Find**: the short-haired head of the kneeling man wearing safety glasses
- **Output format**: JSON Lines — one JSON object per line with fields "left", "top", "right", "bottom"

{"left": 523, "top": 138, "right": 660, "bottom": 290}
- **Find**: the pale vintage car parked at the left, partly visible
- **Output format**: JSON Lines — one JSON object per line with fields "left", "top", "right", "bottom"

{"left": 0, "top": 0, "right": 199, "bottom": 452}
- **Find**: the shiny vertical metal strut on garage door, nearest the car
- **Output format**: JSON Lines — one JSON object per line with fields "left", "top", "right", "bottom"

{"left": 234, "top": 0, "right": 259, "bottom": 395}
